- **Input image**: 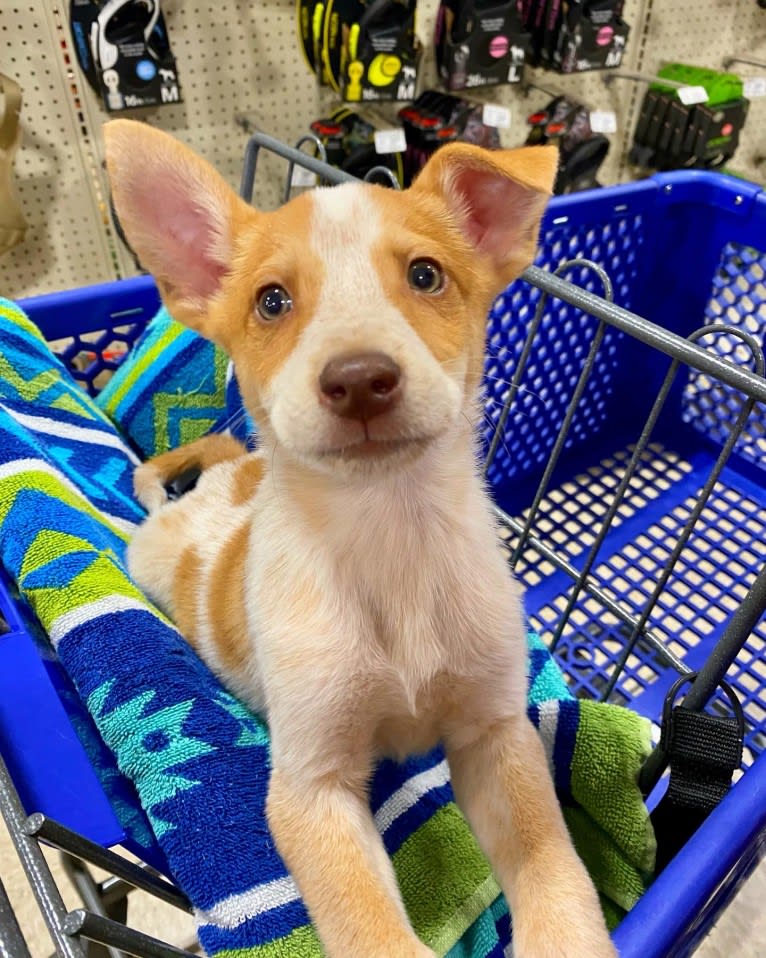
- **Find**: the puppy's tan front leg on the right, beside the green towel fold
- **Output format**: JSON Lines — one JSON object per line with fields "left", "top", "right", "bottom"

{"left": 447, "top": 715, "right": 616, "bottom": 958}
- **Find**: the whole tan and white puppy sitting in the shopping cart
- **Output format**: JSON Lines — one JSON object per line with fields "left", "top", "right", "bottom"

{"left": 106, "top": 120, "right": 615, "bottom": 958}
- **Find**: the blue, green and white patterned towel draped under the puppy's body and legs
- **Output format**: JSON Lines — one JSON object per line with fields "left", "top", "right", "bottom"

{"left": 0, "top": 301, "right": 652, "bottom": 958}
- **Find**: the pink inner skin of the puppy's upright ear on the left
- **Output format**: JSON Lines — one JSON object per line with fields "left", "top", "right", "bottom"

{"left": 124, "top": 165, "right": 227, "bottom": 299}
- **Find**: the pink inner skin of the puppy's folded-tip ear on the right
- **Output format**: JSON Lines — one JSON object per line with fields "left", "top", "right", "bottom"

{"left": 453, "top": 167, "right": 531, "bottom": 260}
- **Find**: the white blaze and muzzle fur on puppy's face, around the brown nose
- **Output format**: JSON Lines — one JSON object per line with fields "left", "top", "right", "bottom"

{"left": 269, "top": 184, "right": 463, "bottom": 457}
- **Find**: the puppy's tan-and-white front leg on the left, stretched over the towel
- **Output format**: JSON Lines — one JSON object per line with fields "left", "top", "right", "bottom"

{"left": 268, "top": 772, "right": 434, "bottom": 958}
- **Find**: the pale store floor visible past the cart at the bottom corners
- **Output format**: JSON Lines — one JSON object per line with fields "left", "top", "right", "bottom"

{"left": 0, "top": 825, "right": 766, "bottom": 958}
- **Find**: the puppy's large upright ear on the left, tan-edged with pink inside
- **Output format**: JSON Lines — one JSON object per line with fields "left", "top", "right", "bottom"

{"left": 104, "top": 120, "right": 258, "bottom": 338}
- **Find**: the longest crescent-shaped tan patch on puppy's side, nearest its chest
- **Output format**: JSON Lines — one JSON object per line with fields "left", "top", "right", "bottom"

{"left": 207, "top": 522, "right": 251, "bottom": 674}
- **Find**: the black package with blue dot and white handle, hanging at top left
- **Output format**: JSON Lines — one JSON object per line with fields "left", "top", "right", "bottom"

{"left": 70, "top": 0, "right": 181, "bottom": 112}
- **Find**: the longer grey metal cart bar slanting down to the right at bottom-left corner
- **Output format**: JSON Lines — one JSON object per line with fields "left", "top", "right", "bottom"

{"left": 0, "top": 758, "right": 85, "bottom": 958}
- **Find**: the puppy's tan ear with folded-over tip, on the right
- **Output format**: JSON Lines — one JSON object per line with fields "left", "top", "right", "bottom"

{"left": 412, "top": 143, "right": 559, "bottom": 283}
